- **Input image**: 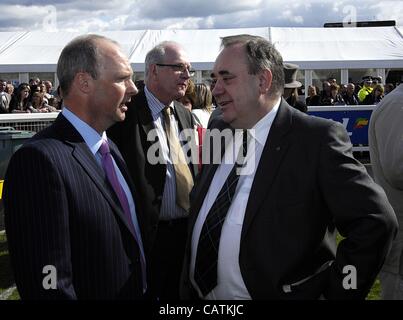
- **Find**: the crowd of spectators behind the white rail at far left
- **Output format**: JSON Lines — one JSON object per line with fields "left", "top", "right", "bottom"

{"left": 0, "top": 78, "right": 62, "bottom": 113}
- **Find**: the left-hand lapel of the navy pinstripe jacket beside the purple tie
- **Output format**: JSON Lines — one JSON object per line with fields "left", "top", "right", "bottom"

{"left": 57, "top": 114, "right": 138, "bottom": 241}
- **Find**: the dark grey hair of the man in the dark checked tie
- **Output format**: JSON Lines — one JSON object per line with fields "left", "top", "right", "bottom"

{"left": 221, "top": 34, "right": 284, "bottom": 96}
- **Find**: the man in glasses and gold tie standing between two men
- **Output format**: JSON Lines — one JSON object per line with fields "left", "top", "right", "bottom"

{"left": 108, "top": 42, "right": 197, "bottom": 299}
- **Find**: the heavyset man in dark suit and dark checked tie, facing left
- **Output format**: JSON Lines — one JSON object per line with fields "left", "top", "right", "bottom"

{"left": 181, "top": 35, "right": 397, "bottom": 299}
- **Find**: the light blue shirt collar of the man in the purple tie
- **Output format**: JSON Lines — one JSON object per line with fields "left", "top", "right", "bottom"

{"left": 62, "top": 105, "right": 108, "bottom": 155}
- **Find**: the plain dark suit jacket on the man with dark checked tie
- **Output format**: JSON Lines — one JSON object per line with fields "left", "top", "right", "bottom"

{"left": 181, "top": 100, "right": 397, "bottom": 299}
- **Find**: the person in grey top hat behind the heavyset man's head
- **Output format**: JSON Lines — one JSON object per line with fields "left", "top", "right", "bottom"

{"left": 283, "top": 63, "right": 308, "bottom": 113}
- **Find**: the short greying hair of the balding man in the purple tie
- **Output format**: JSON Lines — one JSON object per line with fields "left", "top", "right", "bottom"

{"left": 57, "top": 34, "right": 119, "bottom": 97}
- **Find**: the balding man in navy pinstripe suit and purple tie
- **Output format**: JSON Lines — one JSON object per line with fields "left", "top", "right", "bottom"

{"left": 4, "top": 35, "right": 148, "bottom": 299}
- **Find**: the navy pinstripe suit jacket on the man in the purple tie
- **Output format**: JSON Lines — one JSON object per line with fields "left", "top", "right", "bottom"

{"left": 4, "top": 114, "right": 147, "bottom": 299}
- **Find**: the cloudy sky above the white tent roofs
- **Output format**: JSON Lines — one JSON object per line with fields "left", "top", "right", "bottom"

{"left": 0, "top": 0, "right": 403, "bottom": 32}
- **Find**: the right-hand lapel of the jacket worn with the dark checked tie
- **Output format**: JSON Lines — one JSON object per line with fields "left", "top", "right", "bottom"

{"left": 241, "top": 99, "right": 292, "bottom": 241}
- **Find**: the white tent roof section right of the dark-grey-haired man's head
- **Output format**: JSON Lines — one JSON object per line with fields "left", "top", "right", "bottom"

{"left": 271, "top": 27, "right": 403, "bottom": 69}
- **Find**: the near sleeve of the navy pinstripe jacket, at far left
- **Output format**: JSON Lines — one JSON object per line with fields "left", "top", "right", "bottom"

{"left": 4, "top": 146, "right": 76, "bottom": 299}
